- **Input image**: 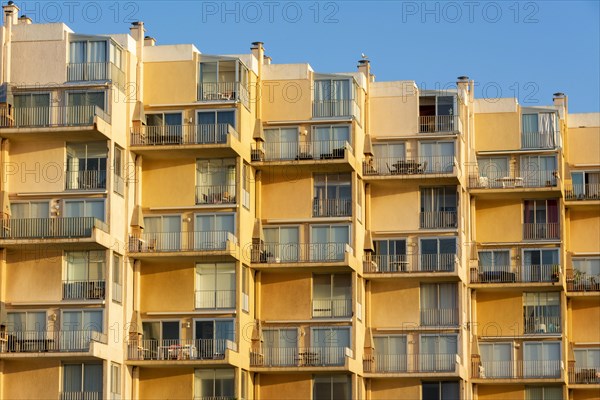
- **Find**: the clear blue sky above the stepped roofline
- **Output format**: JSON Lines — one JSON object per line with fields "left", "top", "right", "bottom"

{"left": 22, "top": 0, "right": 600, "bottom": 112}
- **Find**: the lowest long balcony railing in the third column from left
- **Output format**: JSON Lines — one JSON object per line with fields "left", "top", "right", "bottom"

{"left": 250, "top": 347, "right": 352, "bottom": 367}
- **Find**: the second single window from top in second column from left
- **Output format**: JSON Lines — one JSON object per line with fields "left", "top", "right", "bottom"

{"left": 196, "top": 158, "right": 236, "bottom": 204}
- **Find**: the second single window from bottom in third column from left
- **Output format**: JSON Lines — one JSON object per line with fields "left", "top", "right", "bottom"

{"left": 312, "top": 274, "right": 352, "bottom": 318}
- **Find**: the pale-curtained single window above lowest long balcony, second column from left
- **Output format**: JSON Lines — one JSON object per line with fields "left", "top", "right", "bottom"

{"left": 196, "top": 263, "right": 235, "bottom": 309}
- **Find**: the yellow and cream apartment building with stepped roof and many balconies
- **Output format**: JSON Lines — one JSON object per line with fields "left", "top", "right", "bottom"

{"left": 0, "top": 4, "right": 600, "bottom": 400}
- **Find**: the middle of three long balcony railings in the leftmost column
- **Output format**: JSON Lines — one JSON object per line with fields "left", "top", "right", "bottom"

{"left": 0, "top": 217, "right": 108, "bottom": 239}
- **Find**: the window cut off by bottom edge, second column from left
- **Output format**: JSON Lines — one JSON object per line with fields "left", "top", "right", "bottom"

{"left": 194, "top": 368, "right": 235, "bottom": 399}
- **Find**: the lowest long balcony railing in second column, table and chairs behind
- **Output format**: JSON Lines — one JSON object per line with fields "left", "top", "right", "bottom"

{"left": 127, "top": 339, "right": 237, "bottom": 360}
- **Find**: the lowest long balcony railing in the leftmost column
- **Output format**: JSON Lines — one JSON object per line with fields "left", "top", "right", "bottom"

{"left": 0, "top": 330, "right": 107, "bottom": 353}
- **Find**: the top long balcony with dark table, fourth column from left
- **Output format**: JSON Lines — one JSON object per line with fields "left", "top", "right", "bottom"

{"left": 363, "top": 156, "right": 458, "bottom": 177}
